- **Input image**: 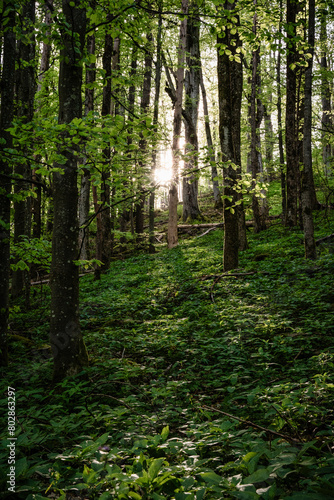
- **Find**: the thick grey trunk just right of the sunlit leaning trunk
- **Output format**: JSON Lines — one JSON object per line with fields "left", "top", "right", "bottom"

{"left": 182, "top": 2, "right": 201, "bottom": 221}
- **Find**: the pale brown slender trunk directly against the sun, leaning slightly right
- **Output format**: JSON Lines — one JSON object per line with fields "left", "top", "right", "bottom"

{"left": 167, "top": 0, "right": 188, "bottom": 248}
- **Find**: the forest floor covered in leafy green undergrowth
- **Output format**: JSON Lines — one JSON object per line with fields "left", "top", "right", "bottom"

{"left": 0, "top": 182, "right": 334, "bottom": 500}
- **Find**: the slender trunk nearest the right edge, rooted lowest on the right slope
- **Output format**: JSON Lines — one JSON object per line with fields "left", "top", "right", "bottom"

{"left": 301, "top": 0, "right": 317, "bottom": 259}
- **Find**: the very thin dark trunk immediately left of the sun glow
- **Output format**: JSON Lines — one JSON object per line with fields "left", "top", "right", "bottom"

{"left": 149, "top": 13, "right": 162, "bottom": 253}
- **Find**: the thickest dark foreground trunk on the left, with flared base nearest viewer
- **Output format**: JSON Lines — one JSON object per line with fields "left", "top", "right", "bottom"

{"left": 50, "top": 0, "right": 88, "bottom": 381}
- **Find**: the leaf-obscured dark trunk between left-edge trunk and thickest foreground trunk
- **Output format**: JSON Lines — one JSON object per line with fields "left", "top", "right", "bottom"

{"left": 12, "top": 1, "right": 36, "bottom": 300}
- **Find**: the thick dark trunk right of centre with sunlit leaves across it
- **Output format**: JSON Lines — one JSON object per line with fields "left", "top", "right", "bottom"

{"left": 217, "top": 2, "right": 242, "bottom": 271}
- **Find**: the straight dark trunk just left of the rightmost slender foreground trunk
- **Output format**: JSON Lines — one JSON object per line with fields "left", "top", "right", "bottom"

{"left": 285, "top": 0, "right": 299, "bottom": 227}
